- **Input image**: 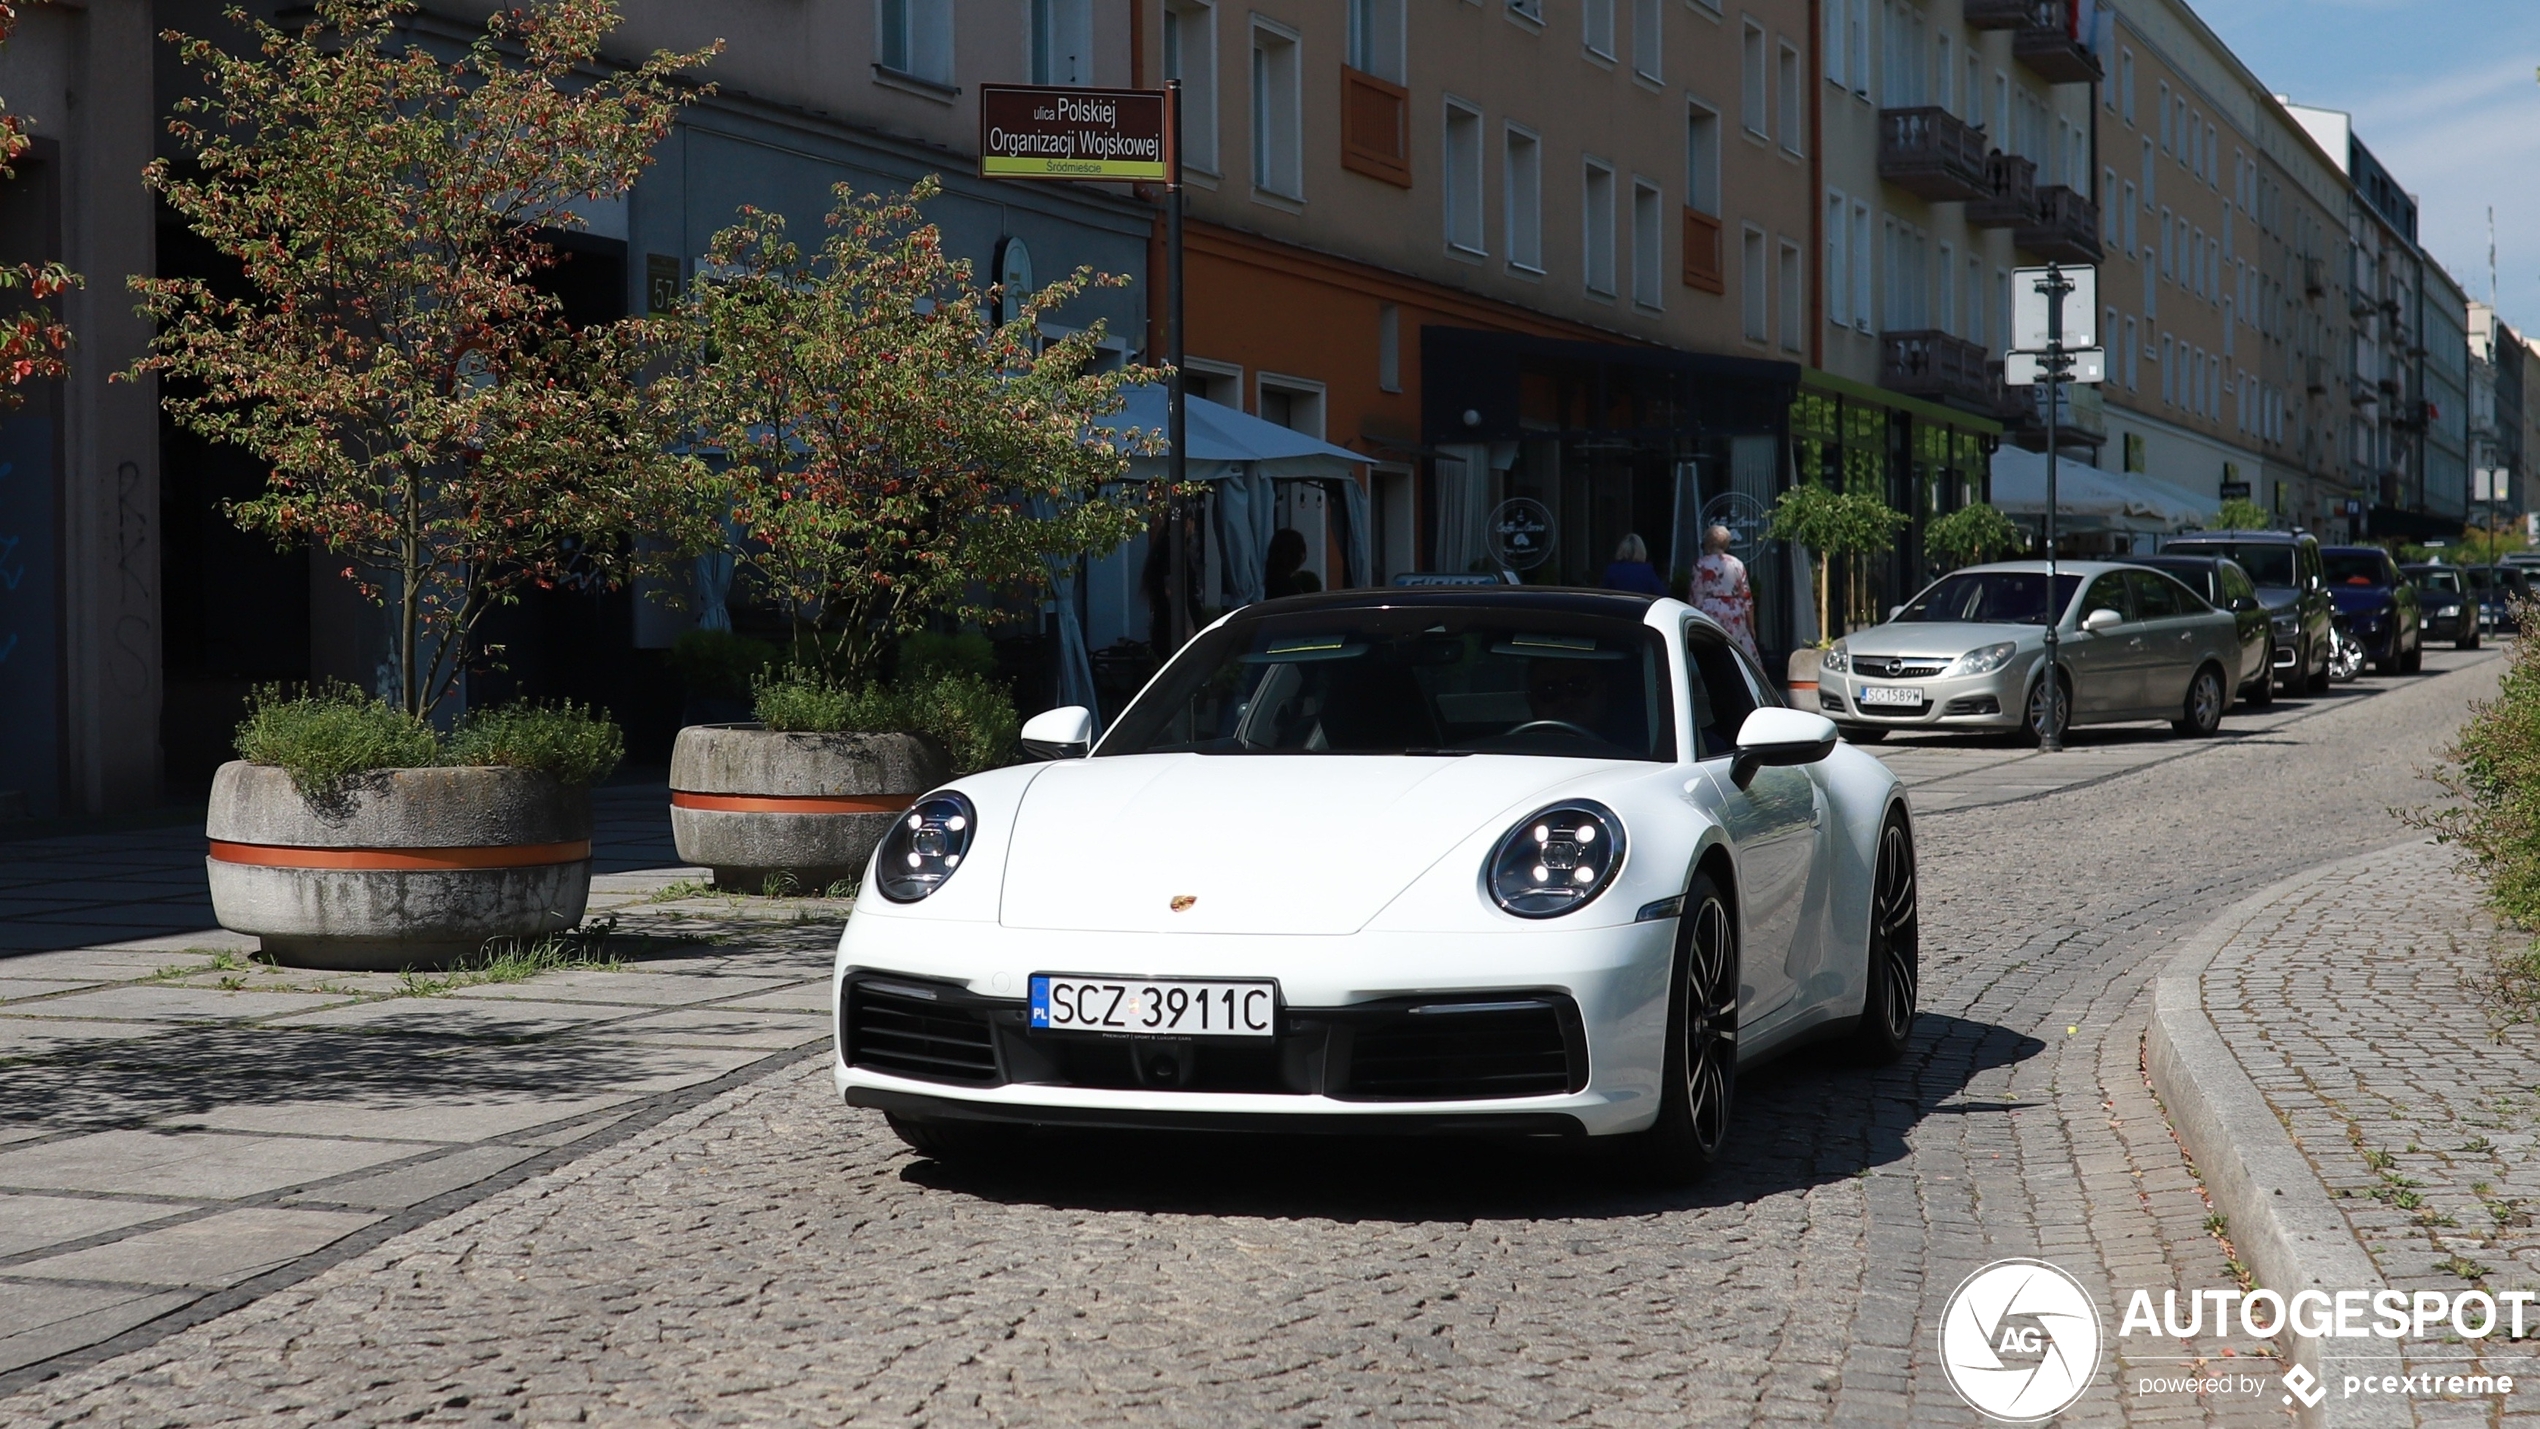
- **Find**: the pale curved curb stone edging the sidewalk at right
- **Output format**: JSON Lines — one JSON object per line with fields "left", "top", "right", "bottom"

{"left": 2144, "top": 838, "right": 2423, "bottom": 1429}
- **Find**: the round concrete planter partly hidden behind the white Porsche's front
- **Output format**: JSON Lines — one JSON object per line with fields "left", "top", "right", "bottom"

{"left": 671, "top": 723, "right": 953, "bottom": 893}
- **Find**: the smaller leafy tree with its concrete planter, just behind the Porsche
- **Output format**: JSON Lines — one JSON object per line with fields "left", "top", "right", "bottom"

{"left": 671, "top": 180, "right": 1158, "bottom": 891}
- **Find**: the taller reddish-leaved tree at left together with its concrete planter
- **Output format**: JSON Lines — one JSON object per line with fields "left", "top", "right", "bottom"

{"left": 132, "top": 0, "right": 711, "bottom": 962}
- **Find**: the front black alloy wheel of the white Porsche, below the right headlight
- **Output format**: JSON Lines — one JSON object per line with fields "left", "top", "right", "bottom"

{"left": 1636, "top": 873, "right": 1737, "bottom": 1185}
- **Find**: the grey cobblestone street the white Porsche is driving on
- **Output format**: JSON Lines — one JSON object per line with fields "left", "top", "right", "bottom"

{"left": 0, "top": 652, "right": 2527, "bottom": 1426}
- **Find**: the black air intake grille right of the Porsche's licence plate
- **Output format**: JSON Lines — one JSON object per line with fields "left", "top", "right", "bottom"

{"left": 1334, "top": 1000, "right": 1588, "bottom": 1102}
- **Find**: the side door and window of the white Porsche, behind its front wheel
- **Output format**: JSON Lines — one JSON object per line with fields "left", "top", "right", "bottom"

{"left": 1684, "top": 624, "right": 1824, "bottom": 1028}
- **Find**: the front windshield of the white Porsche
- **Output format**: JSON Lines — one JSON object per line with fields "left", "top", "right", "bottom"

{"left": 1097, "top": 604, "right": 1676, "bottom": 761}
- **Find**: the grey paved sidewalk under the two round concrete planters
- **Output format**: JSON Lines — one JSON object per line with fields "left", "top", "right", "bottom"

{"left": 0, "top": 789, "right": 848, "bottom": 1391}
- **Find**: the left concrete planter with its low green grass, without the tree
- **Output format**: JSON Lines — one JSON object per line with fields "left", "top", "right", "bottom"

{"left": 206, "top": 685, "right": 625, "bottom": 970}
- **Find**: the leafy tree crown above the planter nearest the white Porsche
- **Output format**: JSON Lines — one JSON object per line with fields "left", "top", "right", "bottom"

{"left": 683, "top": 180, "right": 1161, "bottom": 688}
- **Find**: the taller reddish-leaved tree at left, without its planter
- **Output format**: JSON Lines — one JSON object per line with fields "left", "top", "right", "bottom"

{"left": 132, "top": 0, "right": 714, "bottom": 716}
